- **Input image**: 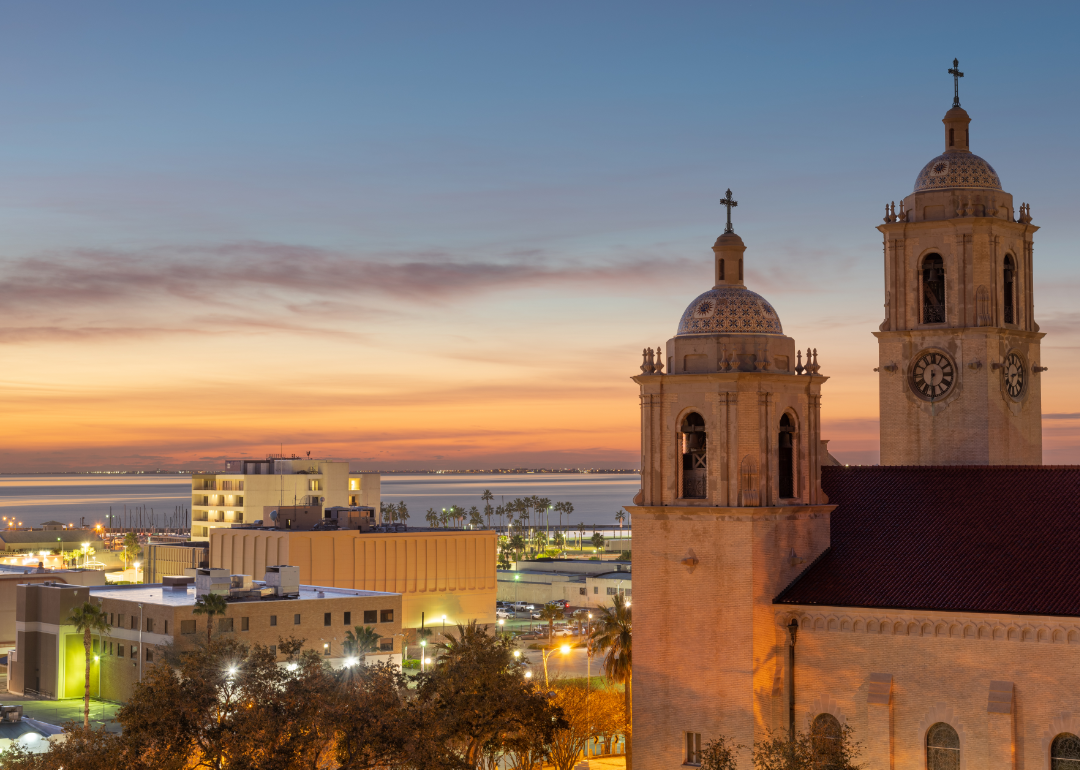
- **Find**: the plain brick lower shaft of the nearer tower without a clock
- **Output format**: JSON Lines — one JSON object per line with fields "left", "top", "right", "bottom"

{"left": 629, "top": 506, "right": 832, "bottom": 770}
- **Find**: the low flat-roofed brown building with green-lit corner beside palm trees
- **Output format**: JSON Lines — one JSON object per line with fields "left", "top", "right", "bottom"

{"left": 8, "top": 570, "right": 402, "bottom": 702}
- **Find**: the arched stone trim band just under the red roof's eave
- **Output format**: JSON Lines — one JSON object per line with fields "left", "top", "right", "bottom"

{"left": 777, "top": 612, "right": 1080, "bottom": 645}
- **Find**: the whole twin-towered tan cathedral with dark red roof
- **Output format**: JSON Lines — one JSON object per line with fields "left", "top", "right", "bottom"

{"left": 629, "top": 63, "right": 1080, "bottom": 770}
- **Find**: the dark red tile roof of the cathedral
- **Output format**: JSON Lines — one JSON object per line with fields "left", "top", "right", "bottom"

{"left": 774, "top": 465, "right": 1080, "bottom": 617}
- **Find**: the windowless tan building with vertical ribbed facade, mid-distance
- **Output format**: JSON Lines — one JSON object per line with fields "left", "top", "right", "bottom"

{"left": 210, "top": 527, "right": 497, "bottom": 629}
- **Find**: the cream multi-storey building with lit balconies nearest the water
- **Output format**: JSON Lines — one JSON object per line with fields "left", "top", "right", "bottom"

{"left": 191, "top": 457, "right": 380, "bottom": 540}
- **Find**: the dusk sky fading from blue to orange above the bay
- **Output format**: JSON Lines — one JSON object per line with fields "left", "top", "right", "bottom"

{"left": 0, "top": 1, "right": 1080, "bottom": 472}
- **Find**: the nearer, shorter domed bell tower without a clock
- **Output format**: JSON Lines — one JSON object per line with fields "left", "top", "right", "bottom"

{"left": 627, "top": 190, "right": 834, "bottom": 769}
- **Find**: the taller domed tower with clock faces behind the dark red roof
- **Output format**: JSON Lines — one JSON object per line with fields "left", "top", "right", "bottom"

{"left": 875, "top": 62, "right": 1045, "bottom": 465}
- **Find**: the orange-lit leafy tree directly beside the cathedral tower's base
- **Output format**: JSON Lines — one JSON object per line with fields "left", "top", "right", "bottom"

{"left": 550, "top": 683, "right": 626, "bottom": 770}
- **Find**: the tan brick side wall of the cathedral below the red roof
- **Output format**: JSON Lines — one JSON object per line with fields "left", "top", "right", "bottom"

{"left": 774, "top": 607, "right": 1080, "bottom": 770}
